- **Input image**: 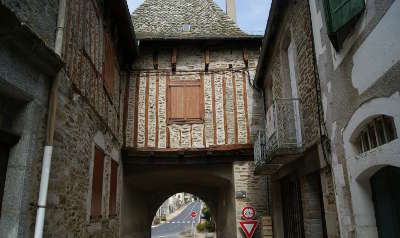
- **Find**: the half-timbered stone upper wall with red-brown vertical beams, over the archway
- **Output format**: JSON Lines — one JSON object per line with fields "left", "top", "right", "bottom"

{"left": 126, "top": 46, "right": 263, "bottom": 149}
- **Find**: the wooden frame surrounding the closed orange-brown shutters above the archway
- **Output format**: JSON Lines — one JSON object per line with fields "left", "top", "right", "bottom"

{"left": 167, "top": 79, "right": 204, "bottom": 124}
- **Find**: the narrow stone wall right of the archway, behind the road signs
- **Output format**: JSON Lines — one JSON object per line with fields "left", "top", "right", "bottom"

{"left": 233, "top": 162, "right": 272, "bottom": 238}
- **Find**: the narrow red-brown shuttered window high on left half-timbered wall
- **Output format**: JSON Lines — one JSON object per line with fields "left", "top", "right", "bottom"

{"left": 103, "top": 33, "right": 115, "bottom": 97}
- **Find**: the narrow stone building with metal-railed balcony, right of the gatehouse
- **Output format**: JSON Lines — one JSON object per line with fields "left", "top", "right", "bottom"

{"left": 254, "top": 0, "right": 339, "bottom": 238}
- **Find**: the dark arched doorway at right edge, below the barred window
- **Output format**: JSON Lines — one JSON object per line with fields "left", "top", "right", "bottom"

{"left": 371, "top": 167, "right": 400, "bottom": 238}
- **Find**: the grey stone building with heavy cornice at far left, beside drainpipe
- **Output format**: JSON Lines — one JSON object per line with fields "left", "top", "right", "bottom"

{"left": 0, "top": 1, "right": 63, "bottom": 237}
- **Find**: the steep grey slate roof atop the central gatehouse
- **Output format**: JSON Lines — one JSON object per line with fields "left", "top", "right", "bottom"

{"left": 132, "top": 0, "right": 248, "bottom": 39}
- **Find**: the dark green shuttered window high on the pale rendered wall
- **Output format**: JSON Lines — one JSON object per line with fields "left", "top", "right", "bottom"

{"left": 324, "top": 0, "right": 365, "bottom": 49}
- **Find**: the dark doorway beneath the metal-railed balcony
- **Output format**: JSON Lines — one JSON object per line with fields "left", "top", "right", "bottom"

{"left": 281, "top": 176, "right": 304, "bottom": 238}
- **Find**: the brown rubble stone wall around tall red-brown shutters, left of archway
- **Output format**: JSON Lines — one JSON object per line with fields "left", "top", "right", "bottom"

{"left": 29, "top": 73, "right": 122, "bottom": 237}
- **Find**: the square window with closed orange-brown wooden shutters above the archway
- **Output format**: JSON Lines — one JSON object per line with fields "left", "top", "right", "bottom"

{"left": 168, "top": 80, "right": 203, "bottom": 124}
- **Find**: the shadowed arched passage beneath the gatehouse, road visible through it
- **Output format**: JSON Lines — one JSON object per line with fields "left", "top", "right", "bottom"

{"left": 121, "top": 163, "right": 236, "bottom": 238}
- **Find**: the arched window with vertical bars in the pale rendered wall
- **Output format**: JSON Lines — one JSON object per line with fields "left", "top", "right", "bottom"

{"left": 357, "top": 116, "right": 397, "bottom": 153}
